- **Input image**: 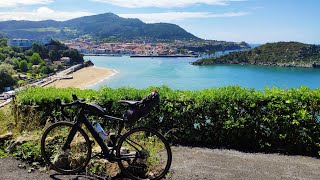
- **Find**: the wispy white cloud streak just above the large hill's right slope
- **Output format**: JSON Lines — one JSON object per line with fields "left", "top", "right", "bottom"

{"left": 119, "top": 12, "right": 249, "bottom": 23}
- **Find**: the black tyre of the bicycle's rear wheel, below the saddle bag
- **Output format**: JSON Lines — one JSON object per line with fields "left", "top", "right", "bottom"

{"left": 116, "top": 128, "right": 172, "bottom": 180}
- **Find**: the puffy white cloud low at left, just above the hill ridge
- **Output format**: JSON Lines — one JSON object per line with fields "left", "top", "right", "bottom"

{"left": 0, "top": 7, "right": 93, "bottom": 21}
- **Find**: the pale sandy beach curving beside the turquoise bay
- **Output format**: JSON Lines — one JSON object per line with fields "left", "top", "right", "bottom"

{"left": 47, "top": 66, "right": 114, "bottom": 89}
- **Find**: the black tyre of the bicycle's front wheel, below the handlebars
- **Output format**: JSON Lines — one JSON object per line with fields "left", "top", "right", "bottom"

{"left": 41, "top": 121, "right": 92, "bottom": 174}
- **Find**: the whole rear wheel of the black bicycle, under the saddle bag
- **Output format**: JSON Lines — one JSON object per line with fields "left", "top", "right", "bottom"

{"left": 116, "top": 128, "right": 172, "bottom": 180}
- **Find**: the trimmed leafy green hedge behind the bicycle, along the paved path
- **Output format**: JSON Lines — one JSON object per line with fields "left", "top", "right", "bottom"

{"left": 16, "top": 86, "right": 320, "bottom": 156}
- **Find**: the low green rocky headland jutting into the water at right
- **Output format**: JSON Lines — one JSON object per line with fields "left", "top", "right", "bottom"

{"left": 192, "top": 42, "right": 320, "bottom": 67}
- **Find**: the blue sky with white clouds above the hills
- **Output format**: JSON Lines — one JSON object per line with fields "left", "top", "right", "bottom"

{"left": 0, "top": 0, "right": 320, "bottom": 44}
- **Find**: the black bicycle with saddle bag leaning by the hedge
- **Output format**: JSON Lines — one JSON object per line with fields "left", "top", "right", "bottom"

{"left": 41, "top": 91, "right": 172, "bottom": 179}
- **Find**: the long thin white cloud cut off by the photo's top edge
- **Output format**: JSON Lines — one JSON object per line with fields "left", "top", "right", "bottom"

{"left": 91, "top": 0, "right": 246, "bottom": 8}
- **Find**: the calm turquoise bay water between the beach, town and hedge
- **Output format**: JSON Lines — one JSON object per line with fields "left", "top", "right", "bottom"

{"left": 85, "top": 56, "right": 320, "bottom": 90}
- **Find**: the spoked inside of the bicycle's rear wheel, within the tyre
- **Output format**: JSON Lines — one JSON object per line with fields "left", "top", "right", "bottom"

{"left": 120, "top": 131, "right": 168, "bottom": 178}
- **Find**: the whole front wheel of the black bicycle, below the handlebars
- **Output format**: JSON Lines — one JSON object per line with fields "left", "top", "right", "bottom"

{"left": 41, "top": 122, "right": 92, "bottom": 174}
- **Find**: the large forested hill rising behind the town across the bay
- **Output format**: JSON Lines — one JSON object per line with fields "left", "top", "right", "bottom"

{"left": 0, "top": 13, "right": 201, "bottom": 41}
